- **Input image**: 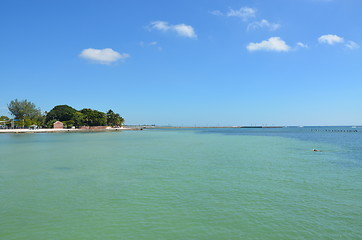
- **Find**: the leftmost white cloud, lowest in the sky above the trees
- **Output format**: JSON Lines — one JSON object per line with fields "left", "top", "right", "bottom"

{"left": 79, "top": 48, "right": 129, "bottom": 64}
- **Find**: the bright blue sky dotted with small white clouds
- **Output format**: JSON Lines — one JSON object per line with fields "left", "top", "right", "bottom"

{"left": 0, "top": 0, "right": 362, "bottom": 126}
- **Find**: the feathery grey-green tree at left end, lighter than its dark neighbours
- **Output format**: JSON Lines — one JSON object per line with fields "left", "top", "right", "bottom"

{"left": 8, "top": 99, "right": 41, "bottom": 120}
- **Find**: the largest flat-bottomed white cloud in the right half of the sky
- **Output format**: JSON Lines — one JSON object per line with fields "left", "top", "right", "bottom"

{"left": 246, "top": 37, "right": 290, "bottom": 52}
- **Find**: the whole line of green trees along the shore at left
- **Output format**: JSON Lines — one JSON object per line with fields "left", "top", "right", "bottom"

{"left": 0, "top": 99, "right": 124, "bottom": 128}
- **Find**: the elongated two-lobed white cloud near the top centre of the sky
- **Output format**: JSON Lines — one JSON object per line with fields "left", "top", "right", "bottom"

{"left": 150, "top": 21, "right": 197, "bottom": 38}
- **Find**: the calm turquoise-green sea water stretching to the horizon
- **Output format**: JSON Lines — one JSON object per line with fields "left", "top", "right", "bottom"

{"left": 0, "top": 128, "right": 362, "bottom": 240}
